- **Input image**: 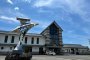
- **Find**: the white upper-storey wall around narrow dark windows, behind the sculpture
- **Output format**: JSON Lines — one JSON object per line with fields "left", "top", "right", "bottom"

{"left": 0, "top": 34, "right": 45, "bottom": 45}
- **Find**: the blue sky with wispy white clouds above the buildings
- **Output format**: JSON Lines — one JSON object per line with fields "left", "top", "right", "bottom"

{"left": 0, "top": 0, "right": 90, "bottom": 47}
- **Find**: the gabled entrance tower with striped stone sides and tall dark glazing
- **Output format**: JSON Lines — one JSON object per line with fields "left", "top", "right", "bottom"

{"left": 41, "top": 21, "right": 63, "bottom": 54}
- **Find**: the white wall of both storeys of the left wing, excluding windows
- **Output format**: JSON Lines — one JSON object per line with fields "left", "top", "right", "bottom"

{"left": 0, "top": 34, "right": 45, "bottom": 54}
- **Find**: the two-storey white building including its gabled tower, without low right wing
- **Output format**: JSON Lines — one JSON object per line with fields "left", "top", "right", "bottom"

{"left": 0, "top": 21, "right": 63, "bottom": 54}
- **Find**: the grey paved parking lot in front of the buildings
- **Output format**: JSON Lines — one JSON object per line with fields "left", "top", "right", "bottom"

{"left": 0, "top": 55, "right": 90, "bottom": 60}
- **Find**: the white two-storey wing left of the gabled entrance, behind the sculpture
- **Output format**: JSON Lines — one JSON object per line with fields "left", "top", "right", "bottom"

{"left": 0, "top": 31, "right": 45, "bottom": 53}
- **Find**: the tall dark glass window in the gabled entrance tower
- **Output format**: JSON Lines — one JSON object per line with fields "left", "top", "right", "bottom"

{"left": 49, "top": 24, "right": 59, "bottom": 46}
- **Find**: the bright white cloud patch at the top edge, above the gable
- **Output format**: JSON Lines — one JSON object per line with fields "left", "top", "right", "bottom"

{"left": 33, "top": 0, "right": 65, "bottom": 8}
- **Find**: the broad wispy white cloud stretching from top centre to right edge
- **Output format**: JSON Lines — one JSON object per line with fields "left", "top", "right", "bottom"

{"left": 33, "top": 0, "right": 90, "bottom": 22}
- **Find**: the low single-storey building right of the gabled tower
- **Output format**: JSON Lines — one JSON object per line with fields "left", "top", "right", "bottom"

{"left": 63, "top": 44, "right": 89, "bottom": 54}
